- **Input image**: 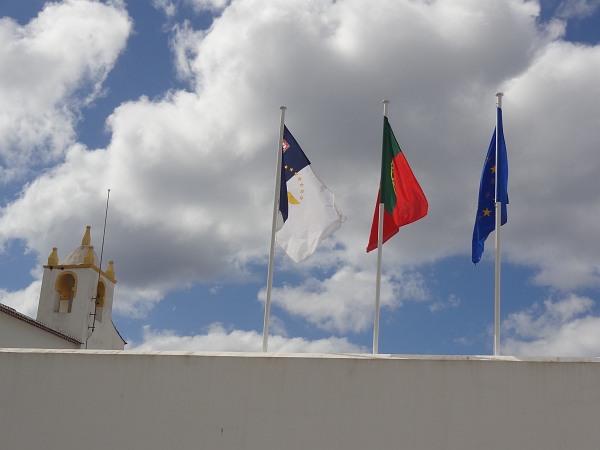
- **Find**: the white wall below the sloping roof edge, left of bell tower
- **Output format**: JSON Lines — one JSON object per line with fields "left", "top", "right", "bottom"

{"left": 0, "top": 311, "right": 79, "bottom": 350}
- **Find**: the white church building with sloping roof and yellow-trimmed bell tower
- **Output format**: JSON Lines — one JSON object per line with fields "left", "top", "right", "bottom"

{"left": 0, "top": 226, "right": 125, "bottom": 350}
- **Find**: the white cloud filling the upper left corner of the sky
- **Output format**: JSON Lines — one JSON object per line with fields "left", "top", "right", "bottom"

{"left": 0, "top": 0, "right": 131, "bottom": 183}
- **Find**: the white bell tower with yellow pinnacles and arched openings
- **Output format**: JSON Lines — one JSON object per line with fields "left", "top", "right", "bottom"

{"left": 37, "top": 226, "right": 125, "bottom": 350}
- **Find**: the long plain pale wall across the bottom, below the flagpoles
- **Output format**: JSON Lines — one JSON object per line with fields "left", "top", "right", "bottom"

{"left": 0, "top": 350, "right": 600, "bottom": 450}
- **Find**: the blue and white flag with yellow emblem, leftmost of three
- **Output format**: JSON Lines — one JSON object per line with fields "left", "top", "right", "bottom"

{"left": 275, "top": 127, "right": 345, "bottom": 262}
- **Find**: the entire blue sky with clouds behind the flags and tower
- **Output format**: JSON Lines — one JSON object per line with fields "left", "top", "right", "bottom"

{"left": 0, "top": 0, "right": 600, "bottom": 356}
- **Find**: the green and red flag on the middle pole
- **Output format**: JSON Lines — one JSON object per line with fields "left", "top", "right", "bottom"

{"left": 367, "top": 116, "right": 429, "bottom": 252}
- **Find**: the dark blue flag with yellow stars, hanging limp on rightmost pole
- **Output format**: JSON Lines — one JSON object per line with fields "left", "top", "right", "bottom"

{"left": 471, "top": 108, "right": 508, "bottom": 264}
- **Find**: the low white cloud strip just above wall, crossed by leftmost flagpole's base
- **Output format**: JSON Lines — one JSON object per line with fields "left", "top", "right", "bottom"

{"left": 127, "top": 323, "right": 365, "bottom": 353}
